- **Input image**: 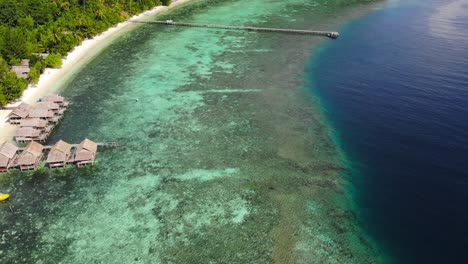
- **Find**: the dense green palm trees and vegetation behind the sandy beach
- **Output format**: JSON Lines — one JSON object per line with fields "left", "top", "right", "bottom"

{"left": 0, "top": 0, "right": 170, "bottom": 105}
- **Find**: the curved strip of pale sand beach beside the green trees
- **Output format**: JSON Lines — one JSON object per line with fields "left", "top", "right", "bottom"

{"left": 0, "top": 0, "right": 190, "bottom": 142}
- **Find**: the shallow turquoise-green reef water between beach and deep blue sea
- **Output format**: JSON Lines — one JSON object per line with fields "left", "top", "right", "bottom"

{"left": 0, "top": 0, "right": 379, "bottom": 263}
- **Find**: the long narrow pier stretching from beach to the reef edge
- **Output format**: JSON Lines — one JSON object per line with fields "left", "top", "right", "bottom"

{"left": 130, "top": 20, "right": 340, "bottom": 39}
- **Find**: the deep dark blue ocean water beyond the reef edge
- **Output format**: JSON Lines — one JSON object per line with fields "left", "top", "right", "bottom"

{"left": 309, "top": 0, "right": 468, "bottom": 263}
